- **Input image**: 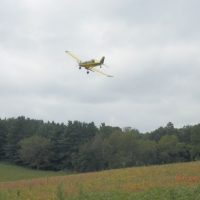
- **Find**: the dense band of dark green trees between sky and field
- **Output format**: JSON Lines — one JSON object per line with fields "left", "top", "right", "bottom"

{"left": 0, "top": 116, "right": 200, "bottom": 172}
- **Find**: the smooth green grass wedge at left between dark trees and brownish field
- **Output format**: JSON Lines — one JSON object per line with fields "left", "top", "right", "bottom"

{"left": 0, "top": 163, "right": 66, "bottom": 182}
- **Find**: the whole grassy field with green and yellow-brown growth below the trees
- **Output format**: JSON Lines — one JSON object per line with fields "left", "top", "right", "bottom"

{"left": 0, "top": 161, "right": 200, "bottom": 200}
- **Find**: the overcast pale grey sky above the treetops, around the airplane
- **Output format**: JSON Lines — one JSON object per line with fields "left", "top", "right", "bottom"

{"left": 0, "top": 0, "right": 200, "bottom": 132}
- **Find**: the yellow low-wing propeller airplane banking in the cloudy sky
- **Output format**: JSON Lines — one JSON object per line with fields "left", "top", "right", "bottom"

{"left": 65, "top": 51, "right": 113, "bottom": 77}
